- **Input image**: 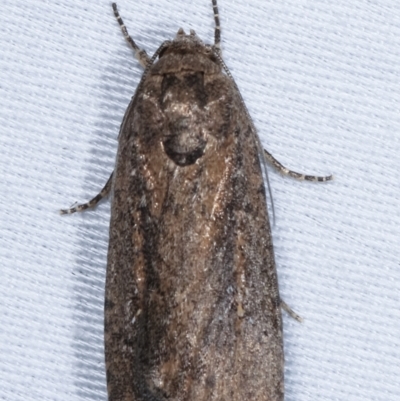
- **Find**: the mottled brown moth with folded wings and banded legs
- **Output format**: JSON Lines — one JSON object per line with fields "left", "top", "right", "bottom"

{"left": 62, "top": 0, "right": 332, "bottom": 401}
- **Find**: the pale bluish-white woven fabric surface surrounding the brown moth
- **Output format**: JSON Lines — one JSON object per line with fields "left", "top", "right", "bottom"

{"left": 0, "top": 0, "right": 400, "bottom": 401}
